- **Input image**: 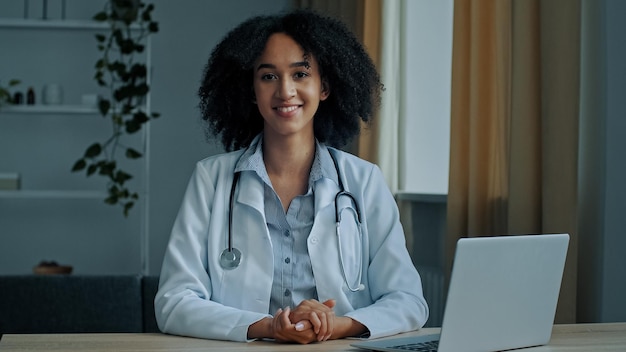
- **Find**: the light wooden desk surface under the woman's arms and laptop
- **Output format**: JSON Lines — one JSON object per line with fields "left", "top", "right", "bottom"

{"left": 0, "top": 323, "right": 626, "bottom": 352}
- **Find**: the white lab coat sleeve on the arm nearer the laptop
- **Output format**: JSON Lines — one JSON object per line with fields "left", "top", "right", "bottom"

{"left": 346, "top": 166, "right": 429, "bottom": 338}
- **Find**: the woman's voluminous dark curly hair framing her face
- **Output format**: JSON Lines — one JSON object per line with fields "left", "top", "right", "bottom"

{"left": 198, "top": 10, "right": 383, "bottom": 151}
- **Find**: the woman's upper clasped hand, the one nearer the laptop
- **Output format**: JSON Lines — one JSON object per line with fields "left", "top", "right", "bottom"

{"left": 289, "top": 299, "right": 335, "bottom": 341}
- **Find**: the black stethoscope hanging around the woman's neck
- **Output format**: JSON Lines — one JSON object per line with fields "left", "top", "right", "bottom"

{"left": 220, "top": 151, "right": 365, "bottom": 292}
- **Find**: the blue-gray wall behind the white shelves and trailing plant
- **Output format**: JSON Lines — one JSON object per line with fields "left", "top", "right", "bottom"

{"left": 0, "top": 0, "right": 291, "bottom": 274}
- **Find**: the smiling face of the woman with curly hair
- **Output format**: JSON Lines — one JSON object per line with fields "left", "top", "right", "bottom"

{"left": 253, "top": 33, "right": 328, "bottom": 142}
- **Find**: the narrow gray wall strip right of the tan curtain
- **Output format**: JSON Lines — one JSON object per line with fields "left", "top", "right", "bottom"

{"left": 578, "top": 0, "right": 626, "bottom": 321}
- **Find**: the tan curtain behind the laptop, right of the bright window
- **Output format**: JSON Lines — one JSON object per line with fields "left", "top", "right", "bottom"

{"left": 445, "top": 0, "right": 580, "bottom": 323}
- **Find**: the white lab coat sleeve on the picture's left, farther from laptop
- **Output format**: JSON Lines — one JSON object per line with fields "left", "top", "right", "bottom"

{"left": 155, "top": 163, "right": 269, "bottom": 341}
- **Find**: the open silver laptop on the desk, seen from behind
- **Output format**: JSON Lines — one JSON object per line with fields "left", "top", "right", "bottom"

{"left": 351, "top": 234, "right": 569, "bottom": 352}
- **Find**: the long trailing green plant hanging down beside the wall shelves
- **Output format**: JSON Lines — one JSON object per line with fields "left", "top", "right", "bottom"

{"left": 72, "top": 0, "right": 159, "bottom": 216}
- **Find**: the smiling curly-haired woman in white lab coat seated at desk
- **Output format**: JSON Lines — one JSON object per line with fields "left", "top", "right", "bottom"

{"left": 155, "top": 11, "right": 428, "bottom": 343}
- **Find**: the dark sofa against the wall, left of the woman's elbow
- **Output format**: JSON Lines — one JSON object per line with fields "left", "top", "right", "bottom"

{"left": 0, "top": 275, "right": 159, "bottom": 335}
